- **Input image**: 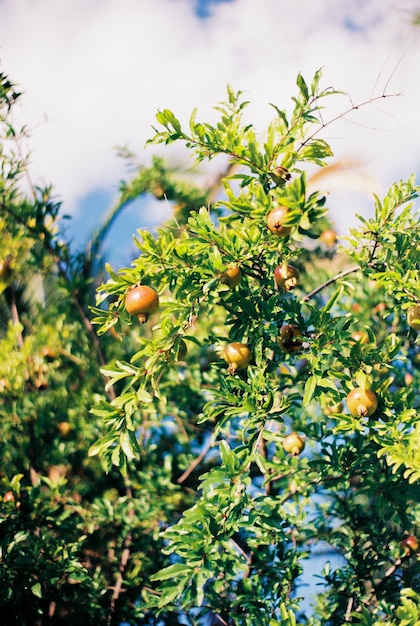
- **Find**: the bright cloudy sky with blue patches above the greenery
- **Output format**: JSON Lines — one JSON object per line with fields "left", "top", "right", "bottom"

{"left": 0, "top": 0, "right": 420, "bottom": 267}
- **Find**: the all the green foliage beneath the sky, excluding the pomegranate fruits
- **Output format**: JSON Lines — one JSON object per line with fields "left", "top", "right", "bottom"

{"left": 0, "top": 72, "right": 420, "bottom": 626}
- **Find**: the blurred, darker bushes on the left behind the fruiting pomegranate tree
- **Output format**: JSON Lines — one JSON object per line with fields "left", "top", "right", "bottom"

{"left": 0, "top": 69, "right": 190, "bottom": 626}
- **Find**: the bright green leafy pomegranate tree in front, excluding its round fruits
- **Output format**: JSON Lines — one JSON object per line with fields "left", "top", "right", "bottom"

{"left": 91, "top": 73, "right": 420, "bottom": 626}
